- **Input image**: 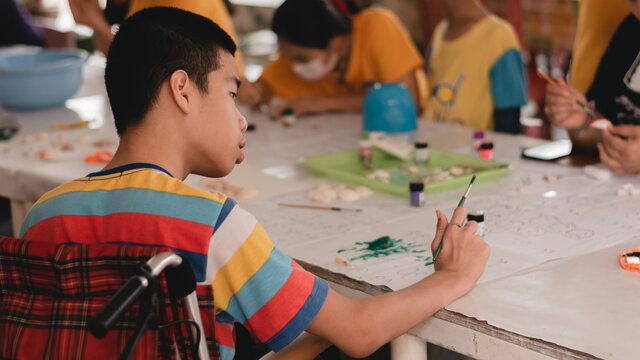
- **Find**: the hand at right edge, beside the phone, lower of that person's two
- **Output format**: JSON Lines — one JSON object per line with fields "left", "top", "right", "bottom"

{"left": 598, "top": 125, "right": 640, "bottom": 174}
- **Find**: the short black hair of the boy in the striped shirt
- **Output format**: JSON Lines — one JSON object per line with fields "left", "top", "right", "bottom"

{"left": 104, "top": 7, "right": 236, "bottom": 135}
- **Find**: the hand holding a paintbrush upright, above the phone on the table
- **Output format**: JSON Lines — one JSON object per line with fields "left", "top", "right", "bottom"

{"left": 544, "top": 80, "right": 588, "bottom": 130}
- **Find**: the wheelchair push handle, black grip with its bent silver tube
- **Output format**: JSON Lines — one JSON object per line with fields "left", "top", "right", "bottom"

{"left": 89, "top": 252, "right": 182, "bottom": 339}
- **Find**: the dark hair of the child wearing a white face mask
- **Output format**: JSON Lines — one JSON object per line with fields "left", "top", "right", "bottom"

{"left": 271, "top": 0, "right": 353, "bottom": 49}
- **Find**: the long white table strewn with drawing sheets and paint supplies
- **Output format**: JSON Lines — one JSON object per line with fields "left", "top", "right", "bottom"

{"left": 0, "top": 61, "right": 640, "bottom": 359}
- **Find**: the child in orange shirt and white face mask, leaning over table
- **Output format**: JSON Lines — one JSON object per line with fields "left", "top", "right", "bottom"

{"left": 239, "top": 0, "right": 427, "bottom": 115}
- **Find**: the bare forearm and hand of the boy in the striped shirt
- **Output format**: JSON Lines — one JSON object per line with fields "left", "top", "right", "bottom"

{"left": 307, "top": 207, "right": 489, "bottom": 357}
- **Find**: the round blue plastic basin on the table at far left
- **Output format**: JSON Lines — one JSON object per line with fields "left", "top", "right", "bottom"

{"left": 0, "top": 49, "right": 88, "bottom": 110}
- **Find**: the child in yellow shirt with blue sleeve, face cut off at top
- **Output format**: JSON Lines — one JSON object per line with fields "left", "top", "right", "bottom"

{"left": 425, "top": 0, "right": 527, "bottom": 133}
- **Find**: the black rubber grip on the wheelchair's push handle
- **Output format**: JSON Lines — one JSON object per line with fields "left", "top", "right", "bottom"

{"left": 89, "top": 275, "right": 149, "bottom": 339}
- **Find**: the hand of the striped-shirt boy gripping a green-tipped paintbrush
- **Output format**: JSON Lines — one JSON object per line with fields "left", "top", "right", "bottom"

{"left": 431, "top": 206, "right": 490, "bottom": 293}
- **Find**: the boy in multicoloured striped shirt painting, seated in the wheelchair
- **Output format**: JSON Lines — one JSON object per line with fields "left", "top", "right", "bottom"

{"left": 21, "top": 7, "right": 489, "bottom": 360}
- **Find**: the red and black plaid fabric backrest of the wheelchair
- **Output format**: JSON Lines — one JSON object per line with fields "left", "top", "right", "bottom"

{"left": 0, "top": 236, "right": 220, "bottom": 359}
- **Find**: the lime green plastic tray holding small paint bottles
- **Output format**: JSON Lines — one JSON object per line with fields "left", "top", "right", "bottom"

{"left": 302, "top": 147, "right": 511, "bottom": 197}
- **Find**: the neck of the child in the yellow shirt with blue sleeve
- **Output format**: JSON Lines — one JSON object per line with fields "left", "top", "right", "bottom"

{"left": 443, "top": 0, "right": 490, "bottom": 40}
